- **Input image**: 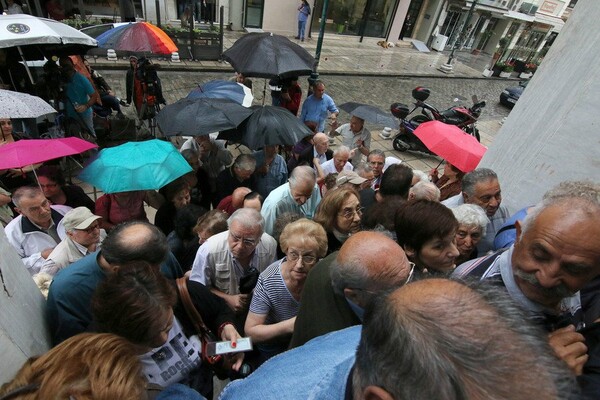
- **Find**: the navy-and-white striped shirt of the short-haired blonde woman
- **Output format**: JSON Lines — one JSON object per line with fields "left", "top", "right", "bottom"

{"left": 250, "top": 257, "right": 300, "bottom": 325}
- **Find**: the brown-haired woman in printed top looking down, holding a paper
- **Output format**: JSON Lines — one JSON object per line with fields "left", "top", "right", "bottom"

{"left": 92, "top": 262, "right": 244, "bottom": 398}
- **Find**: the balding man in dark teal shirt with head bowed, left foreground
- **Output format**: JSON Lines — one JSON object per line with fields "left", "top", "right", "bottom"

{"left": 46, "top": 221, "right": 183, "bottom": 345}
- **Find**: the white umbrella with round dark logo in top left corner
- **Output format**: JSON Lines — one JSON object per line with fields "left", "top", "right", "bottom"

{"left": 0, "top": 14, "right": 97, "bottom": 59}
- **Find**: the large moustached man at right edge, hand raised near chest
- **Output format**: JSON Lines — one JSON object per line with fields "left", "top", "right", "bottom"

{"left": 453, "top": 184, "right": 600, "bottom": 392}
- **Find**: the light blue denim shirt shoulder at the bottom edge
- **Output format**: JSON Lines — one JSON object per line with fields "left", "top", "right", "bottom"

{"left": 219, "top": 325, "right": 361, "bottom": 400}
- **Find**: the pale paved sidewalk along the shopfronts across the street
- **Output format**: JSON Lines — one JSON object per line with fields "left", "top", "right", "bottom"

{"left": 90, "top": 31, "right": 502, "bottom": 79}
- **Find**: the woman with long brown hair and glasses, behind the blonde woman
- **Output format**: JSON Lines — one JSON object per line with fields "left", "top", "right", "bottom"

{"left": 314, "top": 187, "right": 363, "bottom": 254}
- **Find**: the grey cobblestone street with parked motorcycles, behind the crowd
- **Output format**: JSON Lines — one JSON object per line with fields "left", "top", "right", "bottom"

{"left": 101, "top": 70, "right": 515, "bottom": 171}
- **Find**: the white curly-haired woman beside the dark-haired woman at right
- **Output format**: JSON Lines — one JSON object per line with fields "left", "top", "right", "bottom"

{"left": 452, "top": 204, "right": 489, "bottom": 265}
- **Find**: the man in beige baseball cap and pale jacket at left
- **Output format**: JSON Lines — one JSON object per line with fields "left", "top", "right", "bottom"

{"left": 40, "top": 207, "right": 106, "bottom": 276}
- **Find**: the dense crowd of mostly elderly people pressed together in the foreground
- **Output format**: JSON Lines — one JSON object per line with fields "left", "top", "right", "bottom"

{"left": 0, "top": 69, "right": 600, "bottom": 399}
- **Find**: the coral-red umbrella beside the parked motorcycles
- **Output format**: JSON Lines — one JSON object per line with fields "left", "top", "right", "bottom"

{"left": 415, "top": 121, "right": 487, "bottom": 172}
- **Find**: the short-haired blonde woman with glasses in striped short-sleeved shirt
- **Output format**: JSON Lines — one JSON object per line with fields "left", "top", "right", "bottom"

{"left": 244, "top": 218, "right": 327, "bottom": 361}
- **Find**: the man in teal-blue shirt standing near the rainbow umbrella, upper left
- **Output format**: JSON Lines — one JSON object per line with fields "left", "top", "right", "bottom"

{"left": 60, "top": 57, "right": 101, "bottom": 136}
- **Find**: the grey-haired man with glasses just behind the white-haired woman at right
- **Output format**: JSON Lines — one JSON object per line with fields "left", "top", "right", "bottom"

{"left": 442, "top": 168, "right": 510, "bottom": 254}
